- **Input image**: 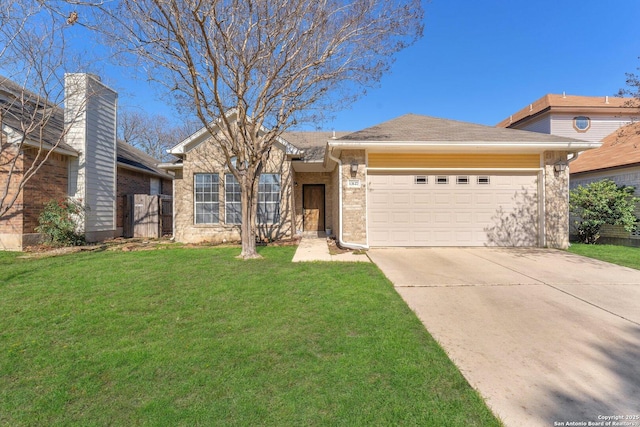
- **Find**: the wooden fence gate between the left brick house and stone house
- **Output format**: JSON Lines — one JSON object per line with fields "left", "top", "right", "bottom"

{"left": 123, "top": 194, "right": 173, "bottom": 239}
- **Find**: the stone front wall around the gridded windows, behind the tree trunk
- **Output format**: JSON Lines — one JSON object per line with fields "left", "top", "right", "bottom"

{"left": 174, "top": 140, "right": 294, "bottom": 243}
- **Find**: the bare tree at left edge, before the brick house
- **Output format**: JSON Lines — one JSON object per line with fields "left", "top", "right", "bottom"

{"left": 0, "top": 0, "right": 81, "bottom": 220}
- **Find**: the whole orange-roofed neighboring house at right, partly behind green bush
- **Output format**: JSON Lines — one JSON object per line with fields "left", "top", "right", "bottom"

{"left": 497, "top": 94, "right": 640, "bottom": 246}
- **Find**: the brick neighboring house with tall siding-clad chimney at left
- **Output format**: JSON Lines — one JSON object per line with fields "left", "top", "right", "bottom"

{"left": 0, "top": 74, "right": 173, "bottom": 250}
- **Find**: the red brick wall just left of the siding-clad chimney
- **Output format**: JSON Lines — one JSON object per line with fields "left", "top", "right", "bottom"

{"left": 22, "top": 148, "right": 69, "bottom": 233}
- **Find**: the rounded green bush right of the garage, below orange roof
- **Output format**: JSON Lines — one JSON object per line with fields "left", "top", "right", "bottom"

{"left": 569, "top": 179, "right": 640, "bottom": 244}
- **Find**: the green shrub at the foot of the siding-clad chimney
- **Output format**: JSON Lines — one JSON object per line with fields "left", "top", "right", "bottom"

{"left": 36, "top": 198, "right": 86, "bottom": 246}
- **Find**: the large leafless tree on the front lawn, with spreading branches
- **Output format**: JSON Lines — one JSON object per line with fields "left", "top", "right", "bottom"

{"left": 76, "top": 0, "right": 423, "bottom": 259}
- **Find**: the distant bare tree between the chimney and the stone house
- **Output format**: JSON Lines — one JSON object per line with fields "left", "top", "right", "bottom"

{"left": 118, "top": 110, "right": 201, "bottom": 161}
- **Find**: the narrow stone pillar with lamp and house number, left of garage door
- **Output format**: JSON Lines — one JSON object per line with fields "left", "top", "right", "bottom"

{"left": 336, "top": 150, "right": 367, "bottom": 245}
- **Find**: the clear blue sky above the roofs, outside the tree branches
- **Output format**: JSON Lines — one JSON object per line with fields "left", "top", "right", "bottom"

{"left": 105, "top": 0, "right": 640, "bottom": 131}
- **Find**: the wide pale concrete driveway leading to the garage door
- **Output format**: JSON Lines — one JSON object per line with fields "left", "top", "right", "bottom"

{"left": 369, "top": 248, "right": 640, "bottom": 427}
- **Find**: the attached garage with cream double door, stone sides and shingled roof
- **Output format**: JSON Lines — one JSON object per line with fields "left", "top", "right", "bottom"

{"left": 326, "top": 114, "right": 599, "bottom": 249}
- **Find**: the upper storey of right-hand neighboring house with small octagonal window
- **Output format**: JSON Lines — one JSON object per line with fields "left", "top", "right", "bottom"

{"left": 496, "top": 94, "right": 640, "bottom": 141}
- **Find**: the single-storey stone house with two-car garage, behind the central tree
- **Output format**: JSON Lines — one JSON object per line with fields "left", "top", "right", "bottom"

{"left": 166, "top": 114, "right": 599, "bottom": 248}
